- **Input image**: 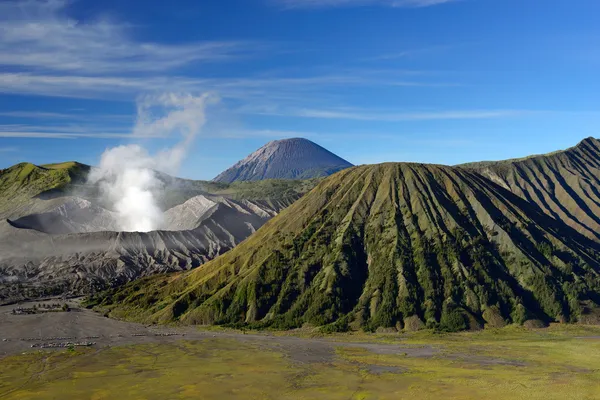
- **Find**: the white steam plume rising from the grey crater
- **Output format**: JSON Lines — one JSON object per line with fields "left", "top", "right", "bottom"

{"left": 88, "top": 94, "right": 214, "bottom": 232}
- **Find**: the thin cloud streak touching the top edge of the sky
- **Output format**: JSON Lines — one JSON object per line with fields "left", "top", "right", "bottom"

{"left": 272, "top": 0, "right": 459, "bottom": 9}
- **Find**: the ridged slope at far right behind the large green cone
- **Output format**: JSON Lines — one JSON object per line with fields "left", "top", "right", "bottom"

{"left": 463, "top": 138, "right": 600, "bottom": 240}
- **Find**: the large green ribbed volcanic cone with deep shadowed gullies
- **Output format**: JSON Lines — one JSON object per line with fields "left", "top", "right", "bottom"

{"left": 103, "top": 163, "right": 600, "bottom": 330}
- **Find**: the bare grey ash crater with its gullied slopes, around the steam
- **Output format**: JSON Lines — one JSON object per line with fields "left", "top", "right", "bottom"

{"left": 0, "top": 190, "right": 308, "bottom": 300}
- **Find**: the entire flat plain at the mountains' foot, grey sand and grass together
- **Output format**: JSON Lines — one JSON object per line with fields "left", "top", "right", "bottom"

{"left": 0, "top": 301, "right": 600, "bottom": 400}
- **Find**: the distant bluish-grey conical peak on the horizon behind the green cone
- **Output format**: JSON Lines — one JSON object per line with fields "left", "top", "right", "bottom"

{"left": 214, "top": 138, "right": 352, "bottom": 183}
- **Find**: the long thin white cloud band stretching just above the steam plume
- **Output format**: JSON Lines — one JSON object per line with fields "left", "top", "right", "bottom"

{"left": 0, "top": 72, "right": 456, "bottom": 101}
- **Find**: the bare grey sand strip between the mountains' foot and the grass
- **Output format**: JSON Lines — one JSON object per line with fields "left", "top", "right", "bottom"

{"left": 0, "top": 300, "right": 439, "bottom": 363}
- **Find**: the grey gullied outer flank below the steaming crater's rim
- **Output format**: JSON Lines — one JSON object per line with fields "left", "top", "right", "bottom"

{"left": 0, "top": 221, "right": 219, "bottom": 300}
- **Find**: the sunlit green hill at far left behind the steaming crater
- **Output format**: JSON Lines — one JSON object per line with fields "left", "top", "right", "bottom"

{"left": 0, "top": 162, "right": 90, "bottom": 215}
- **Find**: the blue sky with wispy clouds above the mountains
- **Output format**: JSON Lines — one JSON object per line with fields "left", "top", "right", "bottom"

{"left": 0, "top": 0, "right": 600, "bottom": 179}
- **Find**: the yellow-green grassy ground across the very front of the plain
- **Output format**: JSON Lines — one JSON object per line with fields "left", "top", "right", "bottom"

{"left": 0, "top": 327, "right": 600, "bottom": 400}
